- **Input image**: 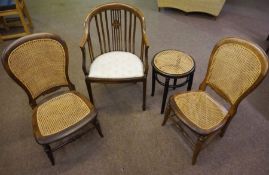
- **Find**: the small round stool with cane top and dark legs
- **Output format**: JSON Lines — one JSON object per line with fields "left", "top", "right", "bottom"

{"left": 151, "top": 50, "right": 195, "bottom": 114}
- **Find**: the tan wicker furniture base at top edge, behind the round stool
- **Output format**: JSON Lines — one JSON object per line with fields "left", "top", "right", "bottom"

{"left": 157, "top": 0, "right": 225, "bottom": 16}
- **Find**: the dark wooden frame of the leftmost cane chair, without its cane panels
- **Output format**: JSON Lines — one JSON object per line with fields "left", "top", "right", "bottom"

{"left": 2, "top": 33, "right": 103, "bottom": 165}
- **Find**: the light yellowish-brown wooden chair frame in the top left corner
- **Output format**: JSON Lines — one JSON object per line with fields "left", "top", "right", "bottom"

{"left": 0, "top": 0, "right": 33, "bottom": 40}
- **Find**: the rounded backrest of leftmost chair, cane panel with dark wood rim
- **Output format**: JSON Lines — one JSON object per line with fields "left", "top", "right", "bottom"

{"left": 2, "top": 33, "right": 73, "bottom": 106}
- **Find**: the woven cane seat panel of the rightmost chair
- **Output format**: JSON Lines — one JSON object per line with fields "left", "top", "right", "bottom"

{"left": 174, "top": 92, "right": 227, "bottom": 129}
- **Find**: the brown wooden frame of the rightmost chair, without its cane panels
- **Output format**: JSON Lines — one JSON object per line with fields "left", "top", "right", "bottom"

{"left": 162, "top": 38, "right": 268, "bottom": 165}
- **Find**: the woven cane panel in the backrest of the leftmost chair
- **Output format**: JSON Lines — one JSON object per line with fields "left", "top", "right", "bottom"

{"left": 8, "top": 39, "right": 68, "bottom": 98}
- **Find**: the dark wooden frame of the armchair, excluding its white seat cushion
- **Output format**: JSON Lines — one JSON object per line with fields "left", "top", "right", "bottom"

{"left": 80, "top": 3, "right": 149, "bottom": 110}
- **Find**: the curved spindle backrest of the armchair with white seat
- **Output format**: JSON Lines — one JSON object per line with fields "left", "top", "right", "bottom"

{"left": 82, "top": 3, "right": 145, "bottom": 60}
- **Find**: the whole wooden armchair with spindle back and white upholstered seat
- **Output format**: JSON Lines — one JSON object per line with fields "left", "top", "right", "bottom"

{"left": 80, "top": 3, "right": 149, "bottom": 110}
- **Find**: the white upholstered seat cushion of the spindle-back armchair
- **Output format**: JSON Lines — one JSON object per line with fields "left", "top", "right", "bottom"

{"left": 89, "top": 51, "right": 144, "bottom": 79}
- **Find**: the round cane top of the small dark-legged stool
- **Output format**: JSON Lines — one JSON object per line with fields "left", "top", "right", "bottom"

{"left": 152, "top": 50, "right": 194, "bottom": 75}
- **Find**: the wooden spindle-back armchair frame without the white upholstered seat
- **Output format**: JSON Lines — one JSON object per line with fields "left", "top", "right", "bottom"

{"left": 80, "top": 3, "right": 149, "bottom": 110}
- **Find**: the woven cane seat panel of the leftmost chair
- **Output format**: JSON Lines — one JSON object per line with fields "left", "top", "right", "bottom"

{"left": 36, "top": 92, "right": 90, "bottom": 136}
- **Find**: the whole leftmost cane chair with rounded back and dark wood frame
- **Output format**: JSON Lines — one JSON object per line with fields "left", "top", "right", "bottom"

{"left": 2, "top": 33, "right": 103, "bottom": 165}
